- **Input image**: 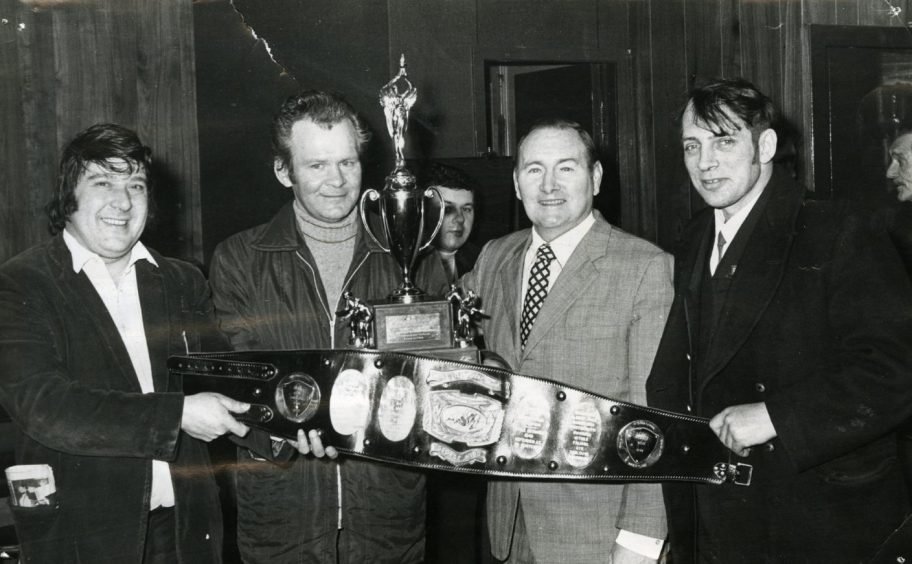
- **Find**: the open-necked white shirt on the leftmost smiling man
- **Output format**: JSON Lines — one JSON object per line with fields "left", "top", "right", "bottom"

{"left": 63, "top": 229, "right": 174, "bottom": 510}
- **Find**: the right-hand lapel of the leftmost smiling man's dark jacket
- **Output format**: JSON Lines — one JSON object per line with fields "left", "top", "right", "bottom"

{"left": 136, "top": 260, "right": 171, "bottom": 392}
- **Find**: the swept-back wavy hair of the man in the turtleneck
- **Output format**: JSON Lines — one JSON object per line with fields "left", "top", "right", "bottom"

{"left": 272, "top": 90, "right": 370, "bottom": 175}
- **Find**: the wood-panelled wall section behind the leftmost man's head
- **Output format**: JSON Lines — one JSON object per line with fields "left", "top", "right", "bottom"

{"left": 0, "top": 0, "right": 202, "bottom": 262}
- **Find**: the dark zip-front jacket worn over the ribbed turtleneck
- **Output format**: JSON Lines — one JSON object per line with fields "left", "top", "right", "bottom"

{"left": 210, "top": 204, "right": 446, "bottom": 563}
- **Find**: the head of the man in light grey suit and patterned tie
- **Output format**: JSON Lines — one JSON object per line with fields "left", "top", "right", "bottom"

{"left": 513, "top": 127, "right": 602, "bottom": 241}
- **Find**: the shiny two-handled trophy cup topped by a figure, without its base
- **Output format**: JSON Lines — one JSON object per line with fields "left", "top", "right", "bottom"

{"left": 359, "top": 55, "right": 446, "bottom": 303}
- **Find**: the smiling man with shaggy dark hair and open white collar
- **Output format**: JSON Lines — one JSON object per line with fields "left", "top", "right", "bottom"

{"left": 0, "top": 124, "right": 248, "bottom": 564}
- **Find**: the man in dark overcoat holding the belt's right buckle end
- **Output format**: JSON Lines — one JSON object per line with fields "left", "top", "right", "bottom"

{"left": 647, "top": 80, "right": 912, "bottom": 564}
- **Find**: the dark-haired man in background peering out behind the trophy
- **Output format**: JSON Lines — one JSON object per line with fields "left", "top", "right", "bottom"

{"left": 421, "top": 163, "right": 479, "bottom": 282}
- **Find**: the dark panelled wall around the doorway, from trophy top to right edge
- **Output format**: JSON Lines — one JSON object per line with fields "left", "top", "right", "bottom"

{"left": 348, "top": 0, "right": 912, "bottom": 247}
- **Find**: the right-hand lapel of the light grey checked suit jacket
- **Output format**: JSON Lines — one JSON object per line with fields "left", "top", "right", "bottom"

{"left": 517, "top": 220, "right": 611, "bottom": 359}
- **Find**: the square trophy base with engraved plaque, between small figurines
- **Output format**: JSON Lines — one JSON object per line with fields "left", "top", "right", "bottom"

{"left": 371, "top": 296, "right": 459, "bottom": 352}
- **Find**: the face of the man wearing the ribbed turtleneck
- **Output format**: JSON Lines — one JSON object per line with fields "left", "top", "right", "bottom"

{"left": 274, "top": 119, "right": 361, "bottom": 223}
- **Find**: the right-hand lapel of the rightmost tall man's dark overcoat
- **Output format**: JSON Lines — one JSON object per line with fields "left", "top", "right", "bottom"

{"left": 700, "top": 172, "right": 803, "bottom": 391}
